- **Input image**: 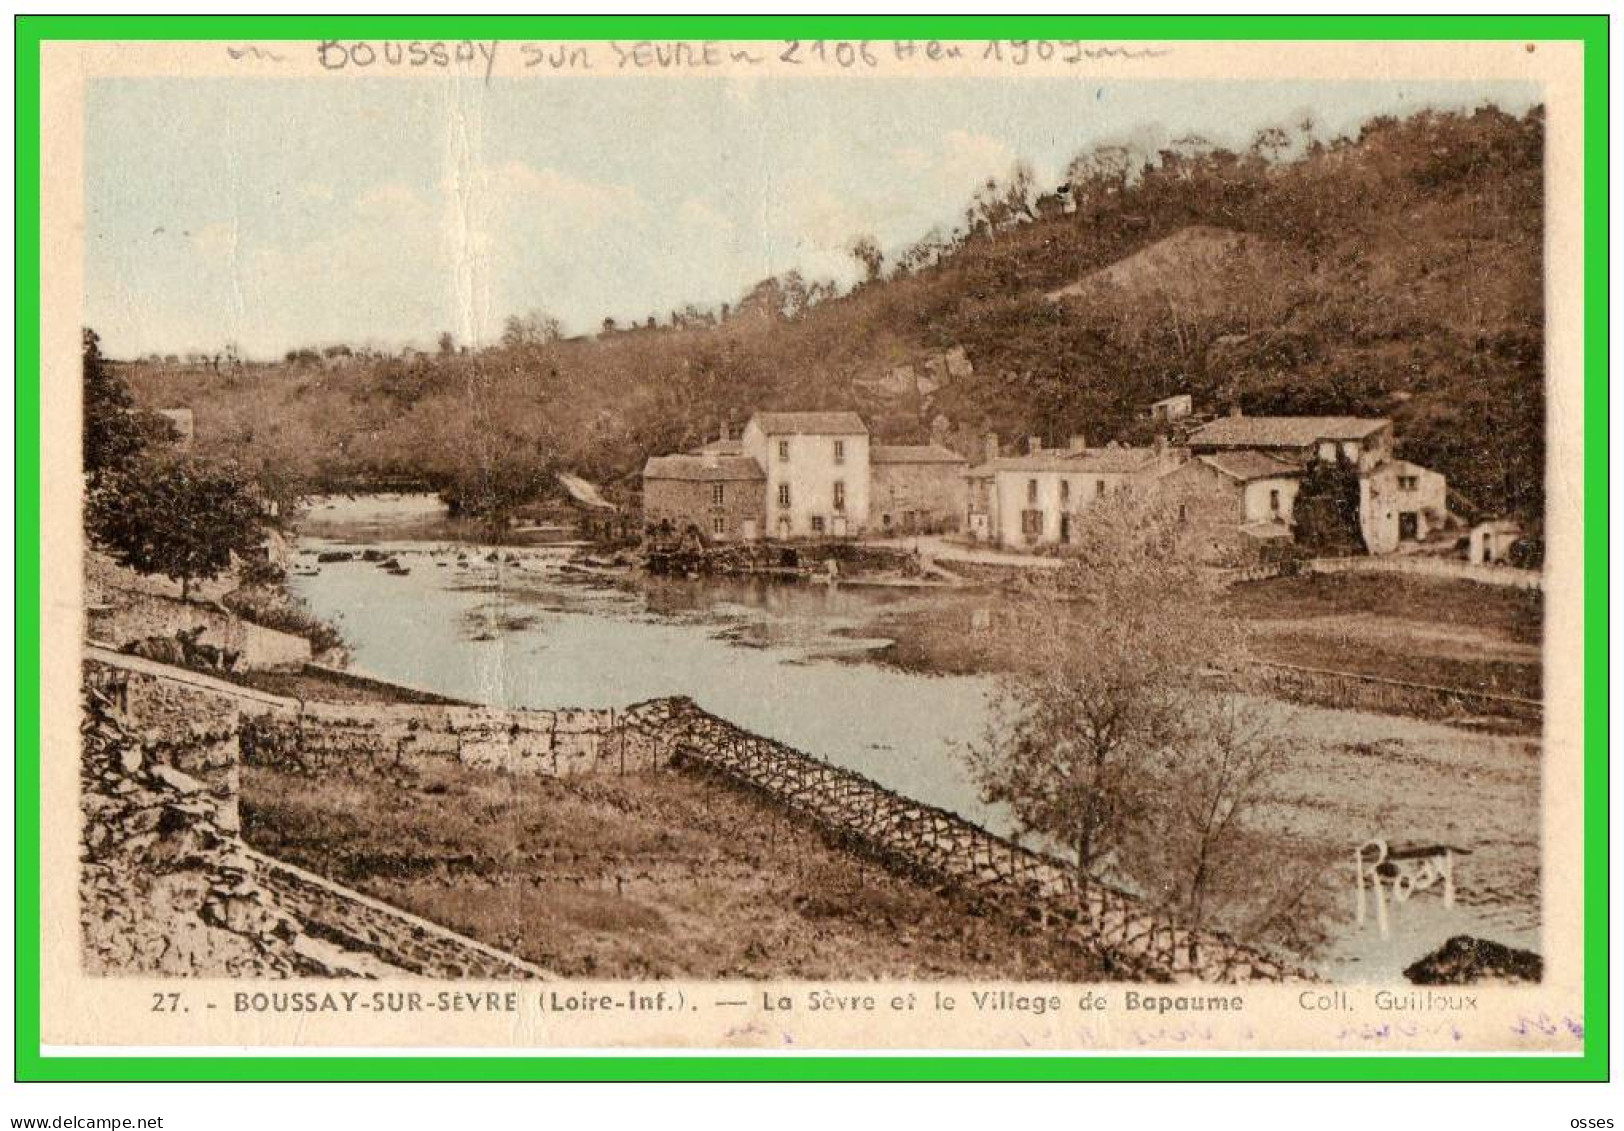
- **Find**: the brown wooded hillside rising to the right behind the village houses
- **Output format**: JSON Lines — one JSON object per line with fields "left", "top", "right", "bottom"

{"left": 120, "top": 109, "right": 1544, "bottom": 523}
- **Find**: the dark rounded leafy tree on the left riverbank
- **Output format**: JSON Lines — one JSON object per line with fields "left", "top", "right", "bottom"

{"left": 84, "top": 457, "right": 265, "bottom": 600}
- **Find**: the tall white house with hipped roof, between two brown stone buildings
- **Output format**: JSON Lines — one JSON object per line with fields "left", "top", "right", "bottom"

{"left": 742, "top": 411, "right": 869, "bottom": 540}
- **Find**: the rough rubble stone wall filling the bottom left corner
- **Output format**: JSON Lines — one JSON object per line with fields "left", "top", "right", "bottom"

{"left": 80, "top": 653, "right": 549, "bottom": 980}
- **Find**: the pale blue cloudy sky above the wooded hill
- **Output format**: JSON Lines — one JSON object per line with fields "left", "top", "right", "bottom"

{"left": 84, "top": 76, "right": 1538, "bottom": 358}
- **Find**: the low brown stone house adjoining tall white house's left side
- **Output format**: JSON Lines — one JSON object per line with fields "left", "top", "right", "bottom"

{"left": 643, "top": 450, "right": 767, "bottom": 543}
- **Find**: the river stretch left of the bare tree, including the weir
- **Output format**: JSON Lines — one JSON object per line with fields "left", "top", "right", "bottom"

{"left": 291, "top": 496, "right": 1012, "bottom": 832}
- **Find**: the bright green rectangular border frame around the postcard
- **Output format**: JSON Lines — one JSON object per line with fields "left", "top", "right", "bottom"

{"left": 15, "top": 15, "right": 1609, "bottom": 1081}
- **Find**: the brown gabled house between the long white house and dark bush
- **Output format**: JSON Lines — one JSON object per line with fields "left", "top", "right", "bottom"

{"left": 1156, "top": 452, "right": 1302, "bottom": 566}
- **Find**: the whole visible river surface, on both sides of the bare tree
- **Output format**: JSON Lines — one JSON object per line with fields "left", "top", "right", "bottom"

{"left": 289, "top": 496, "right": 1540, "bottom": 982}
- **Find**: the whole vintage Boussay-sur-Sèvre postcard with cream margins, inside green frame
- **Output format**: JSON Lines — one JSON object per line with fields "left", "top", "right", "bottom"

{"left": 31, "top": 30, "right": 1605, "bottom": 1056}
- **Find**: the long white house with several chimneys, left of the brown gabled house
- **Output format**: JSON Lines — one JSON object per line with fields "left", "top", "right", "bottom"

{"left": 966, "top": 436, "right": 1179, "bottom": 548}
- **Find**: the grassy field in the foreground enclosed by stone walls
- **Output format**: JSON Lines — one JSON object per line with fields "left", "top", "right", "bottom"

{"left": 242, "top": 754, "right": 1098, "bottom": 980}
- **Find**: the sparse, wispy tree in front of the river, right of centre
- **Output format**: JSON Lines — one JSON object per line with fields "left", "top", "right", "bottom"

{"left": 970, "top": 492, "right": 1234, "bottom": 910}
